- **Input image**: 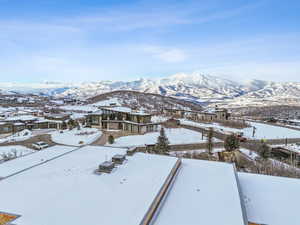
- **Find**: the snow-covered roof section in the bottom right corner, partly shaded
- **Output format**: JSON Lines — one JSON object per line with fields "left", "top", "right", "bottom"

{"left": 238, "top": 173, "right": 300, "bottom": 225}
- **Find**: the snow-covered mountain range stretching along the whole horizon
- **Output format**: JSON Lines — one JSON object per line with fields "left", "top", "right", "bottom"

{"left": 0, "top": 73, "right": 300, "bottom": 106}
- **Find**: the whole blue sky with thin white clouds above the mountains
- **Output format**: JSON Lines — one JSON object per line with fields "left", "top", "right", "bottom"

{"left": 0, "top": 0, "right": 300, "bottom": 82}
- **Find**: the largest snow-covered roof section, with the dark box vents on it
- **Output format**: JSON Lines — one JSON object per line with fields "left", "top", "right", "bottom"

{"left": 0, "top": 146, "right": 177, "bottom": 225}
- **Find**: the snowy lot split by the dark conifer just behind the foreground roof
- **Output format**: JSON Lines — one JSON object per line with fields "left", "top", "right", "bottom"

{"left": 108, "top": 128, "right": 220, "bottom": 147}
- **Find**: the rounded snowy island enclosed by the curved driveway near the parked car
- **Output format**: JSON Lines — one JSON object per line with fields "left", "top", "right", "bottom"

{"left": 51, "top": 128, "right": 102, "bottom": 146}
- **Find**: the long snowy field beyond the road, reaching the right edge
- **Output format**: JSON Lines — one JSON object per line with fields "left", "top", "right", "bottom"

{"left": 180, "top": 119, "right": 300, "bottom": 139}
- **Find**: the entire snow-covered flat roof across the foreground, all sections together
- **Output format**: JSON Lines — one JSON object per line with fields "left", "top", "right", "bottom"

{"left": 0, "top": 146, "right": 300, "bottom": 225}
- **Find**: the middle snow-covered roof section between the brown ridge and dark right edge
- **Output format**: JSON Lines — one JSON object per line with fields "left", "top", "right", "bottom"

{"left": 155, "top": 159, "right": 246, "bottom": 225}
